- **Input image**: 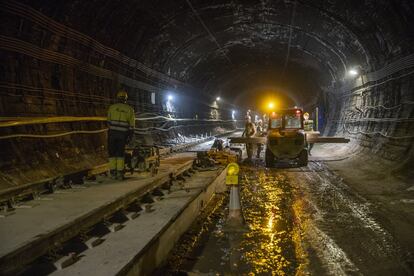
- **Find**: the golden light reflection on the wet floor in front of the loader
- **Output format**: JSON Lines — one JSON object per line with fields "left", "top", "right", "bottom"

{"left": 241, "top": 169, "right": 297, "bottom": 275}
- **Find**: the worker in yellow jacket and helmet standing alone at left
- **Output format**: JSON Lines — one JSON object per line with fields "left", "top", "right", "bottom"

{"left": 108, "top": 90, "right": 135, "bottom": 180}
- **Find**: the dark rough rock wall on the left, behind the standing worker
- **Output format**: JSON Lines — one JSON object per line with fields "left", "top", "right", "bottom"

{"left": 0, "top": 1, "right": 233, "bottom": 189}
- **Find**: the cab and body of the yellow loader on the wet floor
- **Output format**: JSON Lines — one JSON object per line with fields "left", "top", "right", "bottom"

{"left": 265, "top": 108, "right": 308, "bottom": 167}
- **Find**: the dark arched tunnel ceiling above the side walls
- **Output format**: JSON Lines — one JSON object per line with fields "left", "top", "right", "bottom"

{"left": 18, "top": 0, "right": 413, "bottom": 109}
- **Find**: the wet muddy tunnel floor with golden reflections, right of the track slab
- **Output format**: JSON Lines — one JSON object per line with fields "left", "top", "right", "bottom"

{"left": 163, "top": 158, "right": 413, "bottom": 275}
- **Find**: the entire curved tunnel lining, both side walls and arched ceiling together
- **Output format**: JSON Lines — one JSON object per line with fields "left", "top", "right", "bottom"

{"left": 0, "top": 0, "right": 414, "bottom": 187}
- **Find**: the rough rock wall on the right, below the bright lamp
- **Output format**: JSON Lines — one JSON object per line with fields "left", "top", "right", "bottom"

{"left": 325, "top": 58, "right": 414, "bottom": 179}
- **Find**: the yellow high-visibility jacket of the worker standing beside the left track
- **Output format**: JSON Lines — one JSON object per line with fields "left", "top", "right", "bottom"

{"left": 108, "top": 103, "right": 135, "bottom": 131}
